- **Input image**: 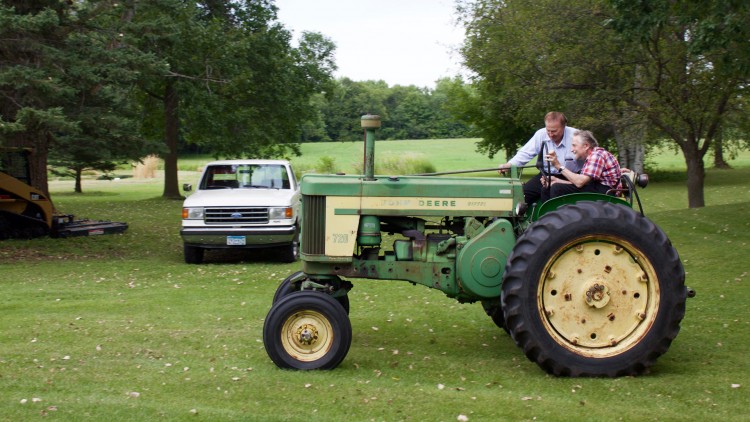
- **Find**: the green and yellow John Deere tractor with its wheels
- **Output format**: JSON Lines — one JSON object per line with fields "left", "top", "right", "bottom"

{"left": 263, "top": 115, "right": 693, "bottom": 377}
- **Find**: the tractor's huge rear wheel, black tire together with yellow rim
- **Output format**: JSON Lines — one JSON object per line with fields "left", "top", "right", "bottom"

{"left": 502, "top": 202, "right": 686, "bottom": 377}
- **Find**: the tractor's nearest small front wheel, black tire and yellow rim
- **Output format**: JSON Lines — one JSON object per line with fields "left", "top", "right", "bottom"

{"left": 263, "top": 291, "right": 352, "bottom": 370}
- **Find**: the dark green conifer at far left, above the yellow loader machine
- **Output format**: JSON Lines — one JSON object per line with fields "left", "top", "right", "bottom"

{"left": 0, "top": 1, "right": 154, "bottom": 195}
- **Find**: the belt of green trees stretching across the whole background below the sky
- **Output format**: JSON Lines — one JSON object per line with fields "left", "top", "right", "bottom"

{"left": 0, "top": 0, "right": 750, "bottom": 207}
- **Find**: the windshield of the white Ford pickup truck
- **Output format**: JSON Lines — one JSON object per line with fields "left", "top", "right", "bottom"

{"left": 201, "top": 164, "right": 291, "bottom": 189}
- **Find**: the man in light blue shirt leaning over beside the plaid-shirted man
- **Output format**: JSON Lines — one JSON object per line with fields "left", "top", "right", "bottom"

{"left": 498, "top": 111, "right": 583, "bottom": 205}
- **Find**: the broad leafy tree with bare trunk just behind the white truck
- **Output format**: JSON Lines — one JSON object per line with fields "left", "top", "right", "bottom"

{"left": 125, "top": 0, "right": 335, "bottom": 198}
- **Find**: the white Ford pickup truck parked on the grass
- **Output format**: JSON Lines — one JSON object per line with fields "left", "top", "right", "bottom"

{"left": 180, "top": 160, "right": 300, "bottom": 264}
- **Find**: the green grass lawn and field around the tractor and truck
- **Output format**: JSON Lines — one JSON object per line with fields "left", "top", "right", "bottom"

{"left": 0, "top": 141, "right": 750, "bottom": 421}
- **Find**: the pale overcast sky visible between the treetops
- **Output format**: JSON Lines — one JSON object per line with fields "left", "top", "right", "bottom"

{"left": 276, "top": 0, "right": 463, "bottom": 88}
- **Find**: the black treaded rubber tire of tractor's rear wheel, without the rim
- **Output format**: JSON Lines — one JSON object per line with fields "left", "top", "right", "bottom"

{"left": 502, "top": 202, "right": 686, "bottom": 377}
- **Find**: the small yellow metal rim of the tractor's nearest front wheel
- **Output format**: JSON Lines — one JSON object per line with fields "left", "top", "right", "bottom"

{"left": 281, "top": 310, "right": 333, "bottom": 362}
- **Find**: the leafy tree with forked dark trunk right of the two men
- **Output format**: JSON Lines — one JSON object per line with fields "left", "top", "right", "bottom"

{"left": 608, "top": 0, "right": 750, "bottom": 208}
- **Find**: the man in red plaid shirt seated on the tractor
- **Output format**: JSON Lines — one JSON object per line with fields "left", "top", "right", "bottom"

{"left": 542, "top": 130, "right": 621, "bottom": 200}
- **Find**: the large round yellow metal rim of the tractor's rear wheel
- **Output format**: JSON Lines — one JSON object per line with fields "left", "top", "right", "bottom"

{"left": 537, "top": 236, "right": 659, "bottom": 358}
